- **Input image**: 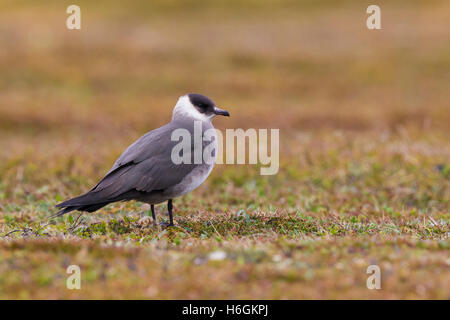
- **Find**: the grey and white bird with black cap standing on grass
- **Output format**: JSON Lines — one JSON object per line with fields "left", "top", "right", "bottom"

{"left": 51, "top": 93, "right": 230, "bottom": 227}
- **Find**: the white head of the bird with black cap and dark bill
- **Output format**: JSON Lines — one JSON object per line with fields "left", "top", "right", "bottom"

{"left": 172, "top": 93, "right": 230, "bottom": 121}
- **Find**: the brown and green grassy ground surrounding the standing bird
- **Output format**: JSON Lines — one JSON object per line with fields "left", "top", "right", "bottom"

{"left": 0, "top": 0, "right": 450, "bottom": 299}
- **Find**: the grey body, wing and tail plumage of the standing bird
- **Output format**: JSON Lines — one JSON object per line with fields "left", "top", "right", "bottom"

{"left": 54, "top": 95, "right": 229, "bottom": 224}
